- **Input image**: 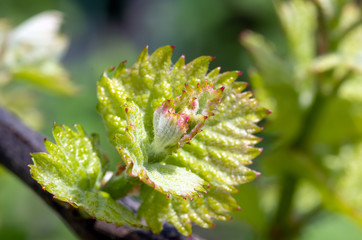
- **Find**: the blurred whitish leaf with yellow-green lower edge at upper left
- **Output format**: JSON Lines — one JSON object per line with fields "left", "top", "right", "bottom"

{"left": 0, "top": 11, "right": 77, "bottom": 94}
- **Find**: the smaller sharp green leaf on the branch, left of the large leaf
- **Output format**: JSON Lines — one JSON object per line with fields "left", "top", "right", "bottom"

{"left": 30, "top": 124, "right": 140, "bottom": 226}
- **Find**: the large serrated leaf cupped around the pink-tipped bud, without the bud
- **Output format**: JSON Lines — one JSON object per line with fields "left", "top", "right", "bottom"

{"left": 98, "top": 46, "right": 266, "bottom": 197}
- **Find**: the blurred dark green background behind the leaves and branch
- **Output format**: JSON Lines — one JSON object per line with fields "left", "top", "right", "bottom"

{"left": 0, "top": 0, "right": 362, "bottom": 240}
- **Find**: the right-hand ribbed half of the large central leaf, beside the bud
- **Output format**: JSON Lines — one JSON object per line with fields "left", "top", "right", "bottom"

{"left": 168, "top": 85, "right": 266, "bottom": 192}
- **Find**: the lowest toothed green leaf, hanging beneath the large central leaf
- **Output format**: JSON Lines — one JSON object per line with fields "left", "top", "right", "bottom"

{"left": 138, "top": 186, "right": 240, "bottom": 235}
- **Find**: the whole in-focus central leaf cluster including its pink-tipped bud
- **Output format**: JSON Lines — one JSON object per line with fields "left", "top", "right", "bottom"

{"left": 97, "top": 46, "right": 267, "bottom": 235}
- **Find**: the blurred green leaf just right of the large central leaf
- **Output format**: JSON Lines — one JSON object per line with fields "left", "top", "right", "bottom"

{"left": 241, "top": 32, "right": 304, "bottom": 145}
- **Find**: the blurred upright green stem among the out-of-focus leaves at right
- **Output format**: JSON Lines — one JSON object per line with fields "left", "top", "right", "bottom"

{"left": 268, "top": 0, "right": 332, "bottom": 240}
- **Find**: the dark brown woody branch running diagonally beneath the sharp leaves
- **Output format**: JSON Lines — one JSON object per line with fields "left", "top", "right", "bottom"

{"left": 0, "top": 108, "right": 201, "bottom": 240}
